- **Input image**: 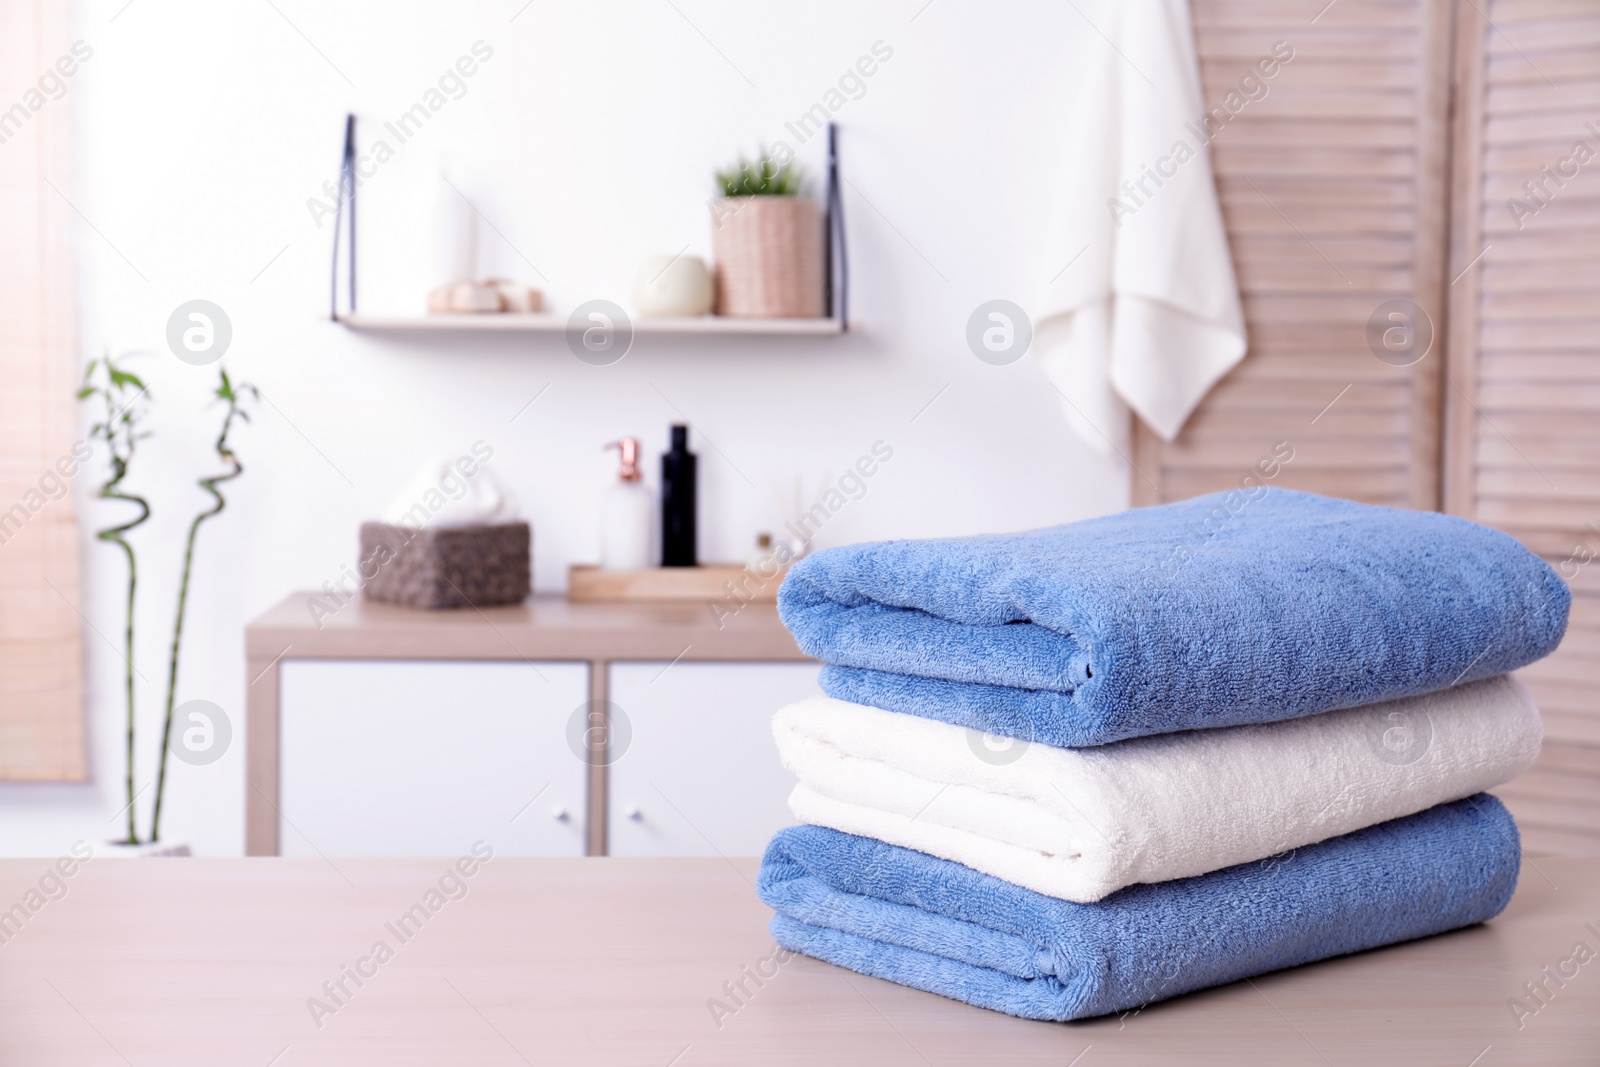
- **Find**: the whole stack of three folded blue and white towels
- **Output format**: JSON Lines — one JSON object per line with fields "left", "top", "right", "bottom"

{"left": 758, "top": 488, "right": 1571, "bottom": 1019}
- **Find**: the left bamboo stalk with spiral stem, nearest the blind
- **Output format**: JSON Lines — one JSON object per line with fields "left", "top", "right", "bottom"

{"left": 78, "top": 355, "right": 150, "bottom": 845}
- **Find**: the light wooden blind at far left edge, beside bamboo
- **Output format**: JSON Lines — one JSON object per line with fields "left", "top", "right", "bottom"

{"left": 0, "top": 0, "right": 88, "bottom": 781}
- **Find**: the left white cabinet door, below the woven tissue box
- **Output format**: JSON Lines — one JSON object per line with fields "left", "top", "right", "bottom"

{"left": 278, "top": 659, "right": 589, "bottom": 856}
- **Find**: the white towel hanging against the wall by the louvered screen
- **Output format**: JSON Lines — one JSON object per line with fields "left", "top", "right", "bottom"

{"left": 1034, "top": 0, "right": 1246, "bottom": 453}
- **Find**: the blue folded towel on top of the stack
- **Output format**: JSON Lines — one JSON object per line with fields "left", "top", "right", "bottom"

{"left": 778, "top": 486, "right": 1571, "bottom": 747}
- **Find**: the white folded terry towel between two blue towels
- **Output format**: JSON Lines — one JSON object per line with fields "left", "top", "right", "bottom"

{"left": 773, "top": 675, "right": 1542, "bottom": 904}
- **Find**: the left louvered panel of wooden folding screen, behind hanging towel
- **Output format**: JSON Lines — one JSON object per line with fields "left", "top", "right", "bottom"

{"left": 1133, "top": 0, "right": 1451, "bottom": 507}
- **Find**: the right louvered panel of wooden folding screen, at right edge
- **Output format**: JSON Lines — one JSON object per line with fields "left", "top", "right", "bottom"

{"left": 1445, "top": 0, "right": 1600, "bottom": 853}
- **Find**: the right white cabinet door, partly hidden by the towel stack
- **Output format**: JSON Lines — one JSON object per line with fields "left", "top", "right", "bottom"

{"left": 608, "top": 662, "right": 821, "bottom": 856}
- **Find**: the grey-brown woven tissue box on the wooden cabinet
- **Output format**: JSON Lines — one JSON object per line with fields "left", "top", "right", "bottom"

{"left": 360, "top": 523, "right": 533, "bottom": 608}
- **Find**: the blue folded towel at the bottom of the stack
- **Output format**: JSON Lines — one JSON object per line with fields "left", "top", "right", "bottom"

{"left": 757, "top": 793, "right": 1520, "bottom": 1019}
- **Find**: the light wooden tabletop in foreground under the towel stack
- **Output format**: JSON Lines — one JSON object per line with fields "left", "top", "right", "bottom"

{"left": 0, "top": 857, "right": 1600, "bottom": 1067}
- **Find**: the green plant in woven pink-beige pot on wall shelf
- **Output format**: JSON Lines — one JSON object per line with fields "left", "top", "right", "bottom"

{"left": 712, "top": 149, "right": 827, "bottom": 318}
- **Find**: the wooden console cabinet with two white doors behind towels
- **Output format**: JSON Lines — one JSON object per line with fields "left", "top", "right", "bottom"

{"left": 245, "top": 593, "right": 818, "bottom": 856}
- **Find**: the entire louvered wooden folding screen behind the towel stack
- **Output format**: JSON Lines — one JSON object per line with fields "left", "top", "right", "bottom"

{"left": 1131, "top": 0, "right": 1600, "bottom": 853}
